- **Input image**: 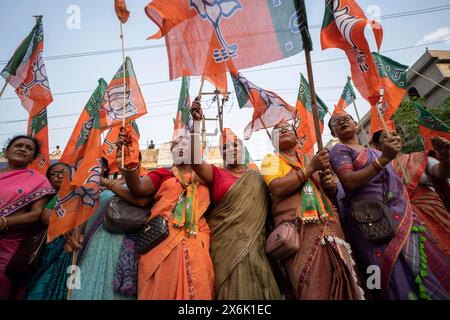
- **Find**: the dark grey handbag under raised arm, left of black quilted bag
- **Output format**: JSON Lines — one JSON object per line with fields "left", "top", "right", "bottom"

{"left": 103, "top": 196, "right": 151, "bottom": 233}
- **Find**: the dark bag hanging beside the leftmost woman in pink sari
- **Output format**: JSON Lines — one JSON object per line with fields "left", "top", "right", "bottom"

{"left": 5, "top": 226, "right": 47, "bottom": 282}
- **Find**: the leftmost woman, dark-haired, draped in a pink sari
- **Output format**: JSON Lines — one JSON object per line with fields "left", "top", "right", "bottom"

{"left": 0, "top": 136, "right": 54, "bottom": 300}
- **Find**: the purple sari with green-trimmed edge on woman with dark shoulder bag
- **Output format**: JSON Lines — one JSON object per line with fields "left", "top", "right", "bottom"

{"left": 330, "top": 144, "right": 450, "bottom": 300}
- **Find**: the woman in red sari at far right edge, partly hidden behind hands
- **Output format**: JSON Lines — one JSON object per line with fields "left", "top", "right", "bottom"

{"left": 372, "top": 121, "right": 450, "bottom": 257}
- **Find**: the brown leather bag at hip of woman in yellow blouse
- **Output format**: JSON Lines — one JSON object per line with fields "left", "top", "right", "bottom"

{"left": 266, "top": 221, "right": 300, "bottom": 260}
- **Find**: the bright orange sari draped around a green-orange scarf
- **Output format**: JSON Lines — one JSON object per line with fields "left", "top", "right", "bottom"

{"left": 138, "top": 173, "right": 215, "bottom": 300}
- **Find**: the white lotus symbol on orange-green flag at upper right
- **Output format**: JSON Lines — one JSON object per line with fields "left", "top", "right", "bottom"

{"left": 333, "top": 0, "right": 369, "bottom": 72}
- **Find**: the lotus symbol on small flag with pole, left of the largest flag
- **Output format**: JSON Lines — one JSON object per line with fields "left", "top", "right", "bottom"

{"left": 102, "top": 83, "right": 137, "bottom": 122}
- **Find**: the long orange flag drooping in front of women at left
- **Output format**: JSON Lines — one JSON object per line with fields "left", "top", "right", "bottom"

{"left": 47, "top": 84, "right": 106, "bottom": 242}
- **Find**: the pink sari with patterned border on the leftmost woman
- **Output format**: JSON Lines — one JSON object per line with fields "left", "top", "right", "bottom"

{"left": 0, "top": 169, "right": 55, "bottom": 300}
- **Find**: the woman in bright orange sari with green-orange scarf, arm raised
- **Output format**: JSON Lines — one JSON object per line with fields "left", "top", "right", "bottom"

{"left": 121, "top": 133, "right": 214, "bottom": 300}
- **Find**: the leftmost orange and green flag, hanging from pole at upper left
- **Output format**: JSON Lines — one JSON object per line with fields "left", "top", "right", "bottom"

{"left": 1, "top": 17, "right": 53, "bottom": 118}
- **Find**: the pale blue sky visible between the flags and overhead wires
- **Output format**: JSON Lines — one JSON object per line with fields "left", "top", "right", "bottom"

{"left": 0, "top": 0, "right": 450, "bottom": 162}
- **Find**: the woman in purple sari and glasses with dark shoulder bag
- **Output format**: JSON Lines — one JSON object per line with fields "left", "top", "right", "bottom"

{"left": 329, "top": 113, "right": 450, "bottom": 300}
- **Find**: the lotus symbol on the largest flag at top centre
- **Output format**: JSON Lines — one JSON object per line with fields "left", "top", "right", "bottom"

{"left": 189, "top": 0, "right": 242, "bottom": 63}
